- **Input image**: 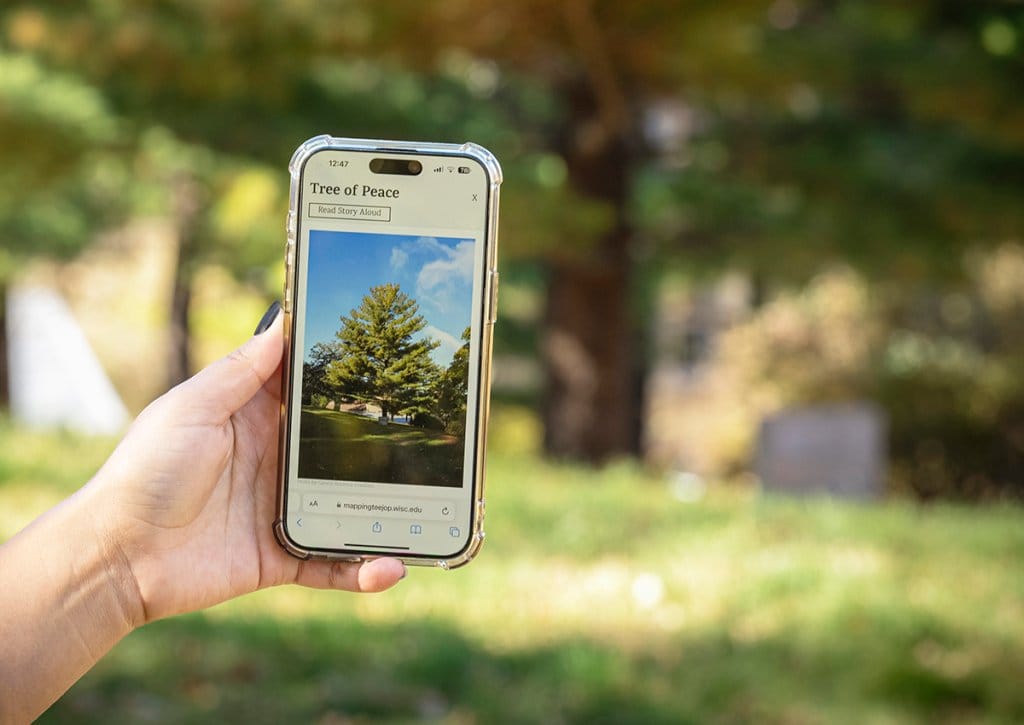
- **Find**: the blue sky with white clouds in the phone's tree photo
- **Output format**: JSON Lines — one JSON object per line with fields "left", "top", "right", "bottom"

{"left": 304, "top": 229, "right": 473, "bottom": 367}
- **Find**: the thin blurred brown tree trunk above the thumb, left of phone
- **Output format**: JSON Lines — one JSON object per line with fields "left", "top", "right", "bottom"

{"left": 167, "top": 174, "right": 202, "bottom": 388}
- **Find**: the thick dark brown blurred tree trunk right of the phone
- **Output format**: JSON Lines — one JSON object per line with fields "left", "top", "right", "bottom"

{"left": 542, "top": 77, "right": 642, "bottom": 463}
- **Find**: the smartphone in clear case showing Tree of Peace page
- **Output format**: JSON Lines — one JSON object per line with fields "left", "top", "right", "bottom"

{"left": 274, "top": 135, "right": 502, "bottom": 568}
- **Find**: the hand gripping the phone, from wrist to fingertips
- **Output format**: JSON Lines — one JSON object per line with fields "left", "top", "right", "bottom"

{"left": 87, "top": 306, "right": 406, "bottom": 626}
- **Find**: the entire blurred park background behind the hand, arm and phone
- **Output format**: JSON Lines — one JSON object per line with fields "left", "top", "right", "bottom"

{"left": 0, "top": 0, "right": 1024, "bottom": 723}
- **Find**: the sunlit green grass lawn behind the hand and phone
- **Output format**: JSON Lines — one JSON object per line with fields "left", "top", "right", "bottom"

{"left": 0, "top": 412, "right": 1024, "bottom": 723}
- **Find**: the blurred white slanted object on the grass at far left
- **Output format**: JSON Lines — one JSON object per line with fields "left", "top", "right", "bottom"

{"left": 7, "top": 287, "right": 128, "bottom": 434}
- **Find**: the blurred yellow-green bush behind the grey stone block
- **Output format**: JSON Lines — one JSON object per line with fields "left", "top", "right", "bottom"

{"left": 675, "top": 264, "right": 1024, "bottom": 501}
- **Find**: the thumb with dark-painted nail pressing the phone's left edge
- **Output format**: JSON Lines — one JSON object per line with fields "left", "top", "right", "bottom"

{"left": 185, "top": 302, "right": 284, "bottom": 420}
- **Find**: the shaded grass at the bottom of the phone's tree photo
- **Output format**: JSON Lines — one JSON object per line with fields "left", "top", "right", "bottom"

{"left": 299, "top": 407, "right": 464, "bottom": 485}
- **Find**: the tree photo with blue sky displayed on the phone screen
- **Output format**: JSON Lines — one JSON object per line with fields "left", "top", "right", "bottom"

{"left": 298, "top": 230, "right": 474, "bottom": 486}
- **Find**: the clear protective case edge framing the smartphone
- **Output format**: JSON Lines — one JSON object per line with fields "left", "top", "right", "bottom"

{"left": 273, "top": 134, "right": 502, "bottom": 569}
